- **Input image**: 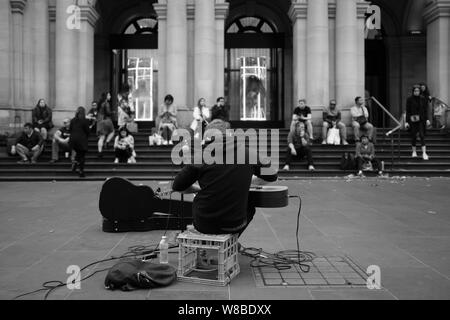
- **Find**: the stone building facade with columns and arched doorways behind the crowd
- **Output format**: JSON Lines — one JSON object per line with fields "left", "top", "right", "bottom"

{"left": 0, "top": 0, "right": 450, "bottom": 132}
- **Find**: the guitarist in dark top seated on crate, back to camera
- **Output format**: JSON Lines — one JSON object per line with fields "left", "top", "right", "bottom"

{"left": 173, "top": 112, "right": 278, "bottom": 235}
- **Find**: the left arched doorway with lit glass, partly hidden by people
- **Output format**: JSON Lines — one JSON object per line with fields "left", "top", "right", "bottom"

{"left": 110, "top": 17, "right": 158, "bottom": 122}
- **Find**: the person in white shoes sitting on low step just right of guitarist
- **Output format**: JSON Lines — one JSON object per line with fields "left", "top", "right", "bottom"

{"left": 283, "top": 115, "right": 315, "bottom": 171}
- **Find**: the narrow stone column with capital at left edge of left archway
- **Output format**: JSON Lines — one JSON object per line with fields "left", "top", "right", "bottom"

{"left": 78, "top": 0, "right": 99, "bottom": 108}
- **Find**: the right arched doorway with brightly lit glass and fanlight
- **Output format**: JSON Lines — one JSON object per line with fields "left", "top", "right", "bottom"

{"left": 225, "top": 15, "right": 285, "bottom": 127}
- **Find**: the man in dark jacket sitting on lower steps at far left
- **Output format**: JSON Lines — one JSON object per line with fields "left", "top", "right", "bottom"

{"left": 12, "top": 123, "right": 44, "bottom": 164}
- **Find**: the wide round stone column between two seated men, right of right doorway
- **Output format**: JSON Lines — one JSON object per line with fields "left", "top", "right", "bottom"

{"left": 306, "top": 0, "right": 330, "bottom": 111}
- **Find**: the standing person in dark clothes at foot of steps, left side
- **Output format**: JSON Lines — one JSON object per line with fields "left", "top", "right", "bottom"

{"left": 69, "top": 107, "right": 90, "bottom": 178}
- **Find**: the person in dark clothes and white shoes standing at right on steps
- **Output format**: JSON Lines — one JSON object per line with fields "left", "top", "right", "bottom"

{"left": 406, "top": 86, "right": 431, "bottom": 160}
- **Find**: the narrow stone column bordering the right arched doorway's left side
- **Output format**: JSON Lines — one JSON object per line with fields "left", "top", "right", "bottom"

{"left": 214, "top": 0, "right": 230, "bottom": 99}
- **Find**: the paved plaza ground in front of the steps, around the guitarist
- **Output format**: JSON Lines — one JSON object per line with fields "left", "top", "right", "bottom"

{"left": 0, "top": 178, "right": 450, "bottom": 300}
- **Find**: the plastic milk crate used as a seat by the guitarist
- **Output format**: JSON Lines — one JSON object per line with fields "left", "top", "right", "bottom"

{"left": 178, "top": 231, "right": 240, "bottom": 286}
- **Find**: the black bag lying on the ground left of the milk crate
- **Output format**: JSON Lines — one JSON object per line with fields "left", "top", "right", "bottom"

{"left": 105, "top": 259, "right": 177, "bottom": 291}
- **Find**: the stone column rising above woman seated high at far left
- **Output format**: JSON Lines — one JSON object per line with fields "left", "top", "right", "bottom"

{"left": 30, "top": 0, "right": 50, "bottom": 102}
